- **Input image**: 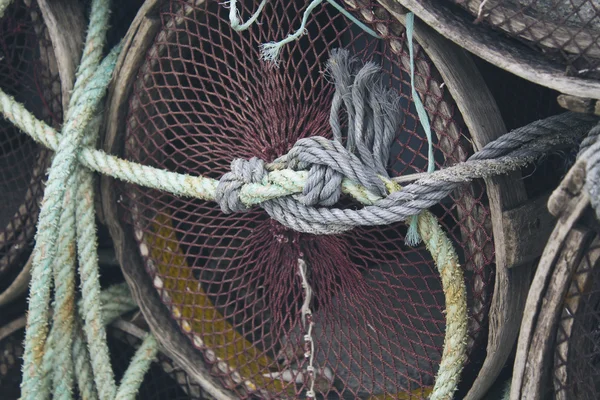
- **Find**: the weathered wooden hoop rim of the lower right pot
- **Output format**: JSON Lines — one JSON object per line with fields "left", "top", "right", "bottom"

{"left": 511, "top": 161, "right": 592, "bottom": 399}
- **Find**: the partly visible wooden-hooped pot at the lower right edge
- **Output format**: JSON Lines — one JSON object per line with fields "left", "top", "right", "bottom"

{"left": 511, "top": 148, "right": 600, "bottom": 399}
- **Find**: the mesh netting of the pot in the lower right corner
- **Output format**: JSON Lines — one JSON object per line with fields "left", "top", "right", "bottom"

{"left": 552, "top": 241, "right": 600, "bottom": 399}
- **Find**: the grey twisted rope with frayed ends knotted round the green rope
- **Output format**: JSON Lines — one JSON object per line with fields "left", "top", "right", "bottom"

{"left": 216, "top": 50, "right": 598, "bottom": 234}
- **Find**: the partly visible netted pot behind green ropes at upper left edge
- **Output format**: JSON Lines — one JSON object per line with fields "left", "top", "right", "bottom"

{"left": 0, "top": 0, "right": 83, "bottom": 305}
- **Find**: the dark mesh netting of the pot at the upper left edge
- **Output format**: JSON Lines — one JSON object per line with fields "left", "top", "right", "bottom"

{"left": 0, "top": 0, "right": 62, "bottom": 282}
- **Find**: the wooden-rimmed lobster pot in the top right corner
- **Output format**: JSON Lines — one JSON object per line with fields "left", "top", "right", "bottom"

{"left": 379, "top": 0, "right": 600, "bottom": 99}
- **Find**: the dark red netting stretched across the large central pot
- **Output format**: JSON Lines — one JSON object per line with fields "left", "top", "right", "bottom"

{"left": 117, "top": 1, "right": 494, "bottom": 398}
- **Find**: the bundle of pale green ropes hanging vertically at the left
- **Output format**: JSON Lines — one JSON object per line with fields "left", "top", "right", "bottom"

{"left": 0, "top": 0, "right": 157, "bottom": 400}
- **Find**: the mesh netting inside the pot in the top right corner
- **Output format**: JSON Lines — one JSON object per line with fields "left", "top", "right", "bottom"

{"left": 447, "top": 0, "right": 600, "bottom": 79}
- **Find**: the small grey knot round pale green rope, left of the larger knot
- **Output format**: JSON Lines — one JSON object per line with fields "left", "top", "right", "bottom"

{"left": 215, "top": 157, "right": 267, "bottom": 214}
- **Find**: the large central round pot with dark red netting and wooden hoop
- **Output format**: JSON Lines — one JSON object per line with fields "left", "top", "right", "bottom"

{"left": 102, "top": 0, "right": 564, "bottom": 398}
